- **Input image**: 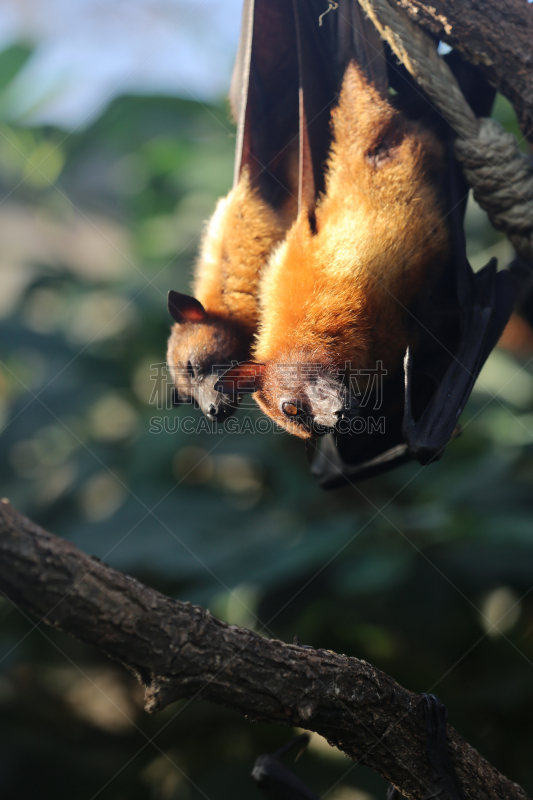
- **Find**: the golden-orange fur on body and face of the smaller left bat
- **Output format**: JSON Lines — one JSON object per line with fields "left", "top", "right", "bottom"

{"left": 167, "top": 163, "right": 297, "bottom": 411}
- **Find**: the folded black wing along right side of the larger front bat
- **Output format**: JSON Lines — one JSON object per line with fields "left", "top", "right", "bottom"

{"left": 311, "top": 18, "right": 517, "bottom": 489}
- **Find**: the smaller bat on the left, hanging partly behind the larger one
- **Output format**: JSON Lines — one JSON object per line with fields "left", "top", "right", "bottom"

{"left": 167, "top": 0, "right": 299, "bottom": 422}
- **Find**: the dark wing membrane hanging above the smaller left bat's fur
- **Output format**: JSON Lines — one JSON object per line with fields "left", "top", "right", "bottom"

{"left": 230, "top": 0, "right": 299, "bottom": 207}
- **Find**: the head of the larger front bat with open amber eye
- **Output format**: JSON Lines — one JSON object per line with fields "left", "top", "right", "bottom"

{"left": 215, "top": 358, "right": 359, "bottom": 439}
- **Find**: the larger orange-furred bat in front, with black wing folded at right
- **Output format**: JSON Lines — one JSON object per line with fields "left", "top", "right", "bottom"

{"left": 217, "top": 0, "right": 515, "bottom": 486}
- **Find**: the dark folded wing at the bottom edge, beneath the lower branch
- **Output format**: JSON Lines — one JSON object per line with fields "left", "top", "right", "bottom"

{"left": 252, "top": 733, "right": 318, "bottom": 800}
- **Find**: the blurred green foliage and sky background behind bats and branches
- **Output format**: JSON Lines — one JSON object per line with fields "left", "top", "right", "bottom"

{"left": 0, "top": 0, "right": 533, "bottom": 800}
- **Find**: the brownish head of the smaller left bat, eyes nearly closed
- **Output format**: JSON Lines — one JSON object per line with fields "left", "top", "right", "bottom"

{"left": 167, "top": 291, "right": 246, "bottom": 422}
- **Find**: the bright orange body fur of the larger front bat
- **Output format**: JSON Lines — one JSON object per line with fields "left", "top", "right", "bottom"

{"left": 254, "top": 63, "right": 450, "bottom": 438}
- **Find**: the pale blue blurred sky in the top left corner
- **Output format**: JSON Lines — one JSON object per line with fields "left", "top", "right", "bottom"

{"left": 0, "top": 0, "right": 242, "bottom": 129}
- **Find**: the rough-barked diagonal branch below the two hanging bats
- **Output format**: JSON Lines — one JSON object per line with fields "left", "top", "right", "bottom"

{"left": 0, "top": 501, "right": 526, "bottom": 800}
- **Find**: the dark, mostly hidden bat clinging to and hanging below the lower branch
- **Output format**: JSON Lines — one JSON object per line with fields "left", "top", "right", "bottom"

{"left": 252, "top": 694, "right": 464, "bottom": 800}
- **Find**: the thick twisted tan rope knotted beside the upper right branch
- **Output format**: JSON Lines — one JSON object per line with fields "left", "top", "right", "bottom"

{"left": 359, "top": 0, "right": 533, "bottom": 260}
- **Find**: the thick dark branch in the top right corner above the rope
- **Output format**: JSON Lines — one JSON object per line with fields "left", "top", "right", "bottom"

{"left": 394, "top": 0, "right": 533, "bottom": 144}
